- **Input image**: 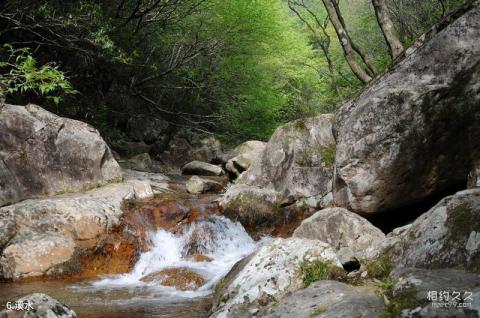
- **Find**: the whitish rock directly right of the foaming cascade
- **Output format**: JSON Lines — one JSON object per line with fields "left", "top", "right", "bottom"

{"left": 212, "top": 238, "right": 341, "bottom": 317}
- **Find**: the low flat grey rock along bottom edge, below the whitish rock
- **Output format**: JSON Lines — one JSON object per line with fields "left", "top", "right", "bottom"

{"left": 262, "top": 280, "right": 384, "bottom": 318}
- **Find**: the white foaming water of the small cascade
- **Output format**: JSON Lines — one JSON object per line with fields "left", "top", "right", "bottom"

{"left": 93, "top": 216, "right": 264, "bottom": 297}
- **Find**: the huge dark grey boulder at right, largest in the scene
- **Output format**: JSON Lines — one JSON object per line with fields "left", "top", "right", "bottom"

{"left": 334, "top": 1, "right": 480, "bottom": 213}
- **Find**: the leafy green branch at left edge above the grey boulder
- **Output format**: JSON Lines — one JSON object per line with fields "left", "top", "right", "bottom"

{"left": 0, "top": 44, "right": 76, "bottom": 104}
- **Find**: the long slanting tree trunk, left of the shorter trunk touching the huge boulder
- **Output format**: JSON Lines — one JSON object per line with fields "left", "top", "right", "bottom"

{"left": 322, "top": 0, "right": 372, "bottom": 84}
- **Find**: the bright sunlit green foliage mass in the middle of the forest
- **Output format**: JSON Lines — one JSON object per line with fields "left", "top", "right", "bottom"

{"left": 203, "top": 0, "right": 326, "bottom": 142}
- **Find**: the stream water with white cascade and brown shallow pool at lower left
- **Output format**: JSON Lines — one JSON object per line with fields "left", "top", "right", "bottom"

{"left": 0, "top": 216, "right": 261, "bottom": 318}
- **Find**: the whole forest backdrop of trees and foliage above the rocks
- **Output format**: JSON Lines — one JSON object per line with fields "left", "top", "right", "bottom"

{"left": 0, "top": 0, "right": 464, "bottom": 144}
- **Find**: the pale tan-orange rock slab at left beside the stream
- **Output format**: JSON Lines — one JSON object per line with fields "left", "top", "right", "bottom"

{"left": 0, "top": 180, "right": 153, "bottom": 280}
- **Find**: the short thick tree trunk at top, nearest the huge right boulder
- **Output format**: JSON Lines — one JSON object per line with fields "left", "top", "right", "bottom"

{"left": 372, "top": 0, "right": 403, "bottom": 59}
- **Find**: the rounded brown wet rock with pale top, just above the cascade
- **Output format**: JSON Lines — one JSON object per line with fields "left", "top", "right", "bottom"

{"left": 220, "top": 185, "right": 283, "bottom": 227}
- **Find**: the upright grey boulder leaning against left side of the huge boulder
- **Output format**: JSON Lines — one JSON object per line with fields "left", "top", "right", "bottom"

{"left": 237, "top": 114, "right": 335, "bottom": 198}
